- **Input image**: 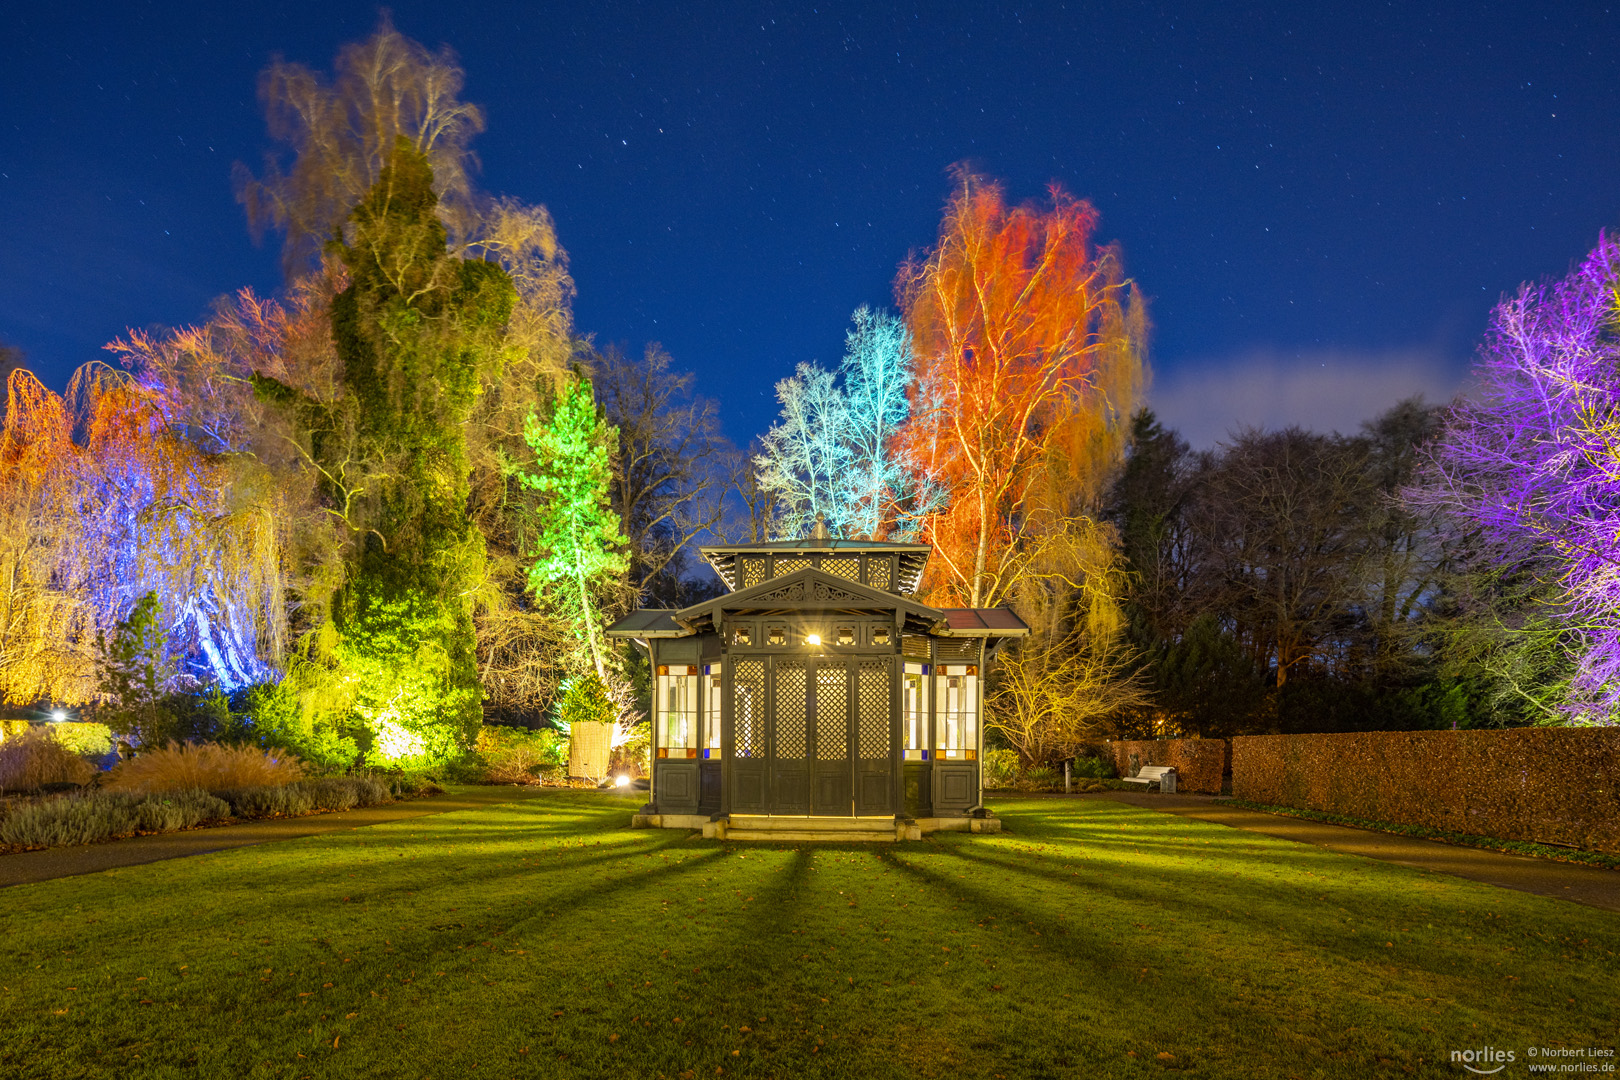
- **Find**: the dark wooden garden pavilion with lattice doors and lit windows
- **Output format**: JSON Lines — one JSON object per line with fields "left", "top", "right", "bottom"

{"left": 608, "top": 523, "right": 1029, "bottom": 839}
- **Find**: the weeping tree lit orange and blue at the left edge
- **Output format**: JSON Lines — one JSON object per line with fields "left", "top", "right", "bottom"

{"left": 0, "top": 356, "right": 285, "bottom": 704}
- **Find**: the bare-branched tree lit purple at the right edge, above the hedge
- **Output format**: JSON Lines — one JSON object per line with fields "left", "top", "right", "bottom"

{"left": 1411, "top": 236, "right": 1620, "bottom": 724}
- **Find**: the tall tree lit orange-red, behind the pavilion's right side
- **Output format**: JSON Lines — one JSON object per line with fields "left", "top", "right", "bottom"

{"left": 897, "top": 173, "right": 1145, "bottom": 607}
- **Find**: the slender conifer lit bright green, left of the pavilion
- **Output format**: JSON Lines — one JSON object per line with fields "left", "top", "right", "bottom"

{"left": 518, "top": 377, "right": 630, "bottom": 680}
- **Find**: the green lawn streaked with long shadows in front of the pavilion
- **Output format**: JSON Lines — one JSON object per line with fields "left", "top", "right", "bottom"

{"left": 0, "top": 792, "right": 1620, "bottom": 1080}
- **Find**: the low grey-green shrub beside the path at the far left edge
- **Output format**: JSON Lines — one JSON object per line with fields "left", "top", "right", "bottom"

{"left": 0, "top": 790, "right": 230, "bottom": 847}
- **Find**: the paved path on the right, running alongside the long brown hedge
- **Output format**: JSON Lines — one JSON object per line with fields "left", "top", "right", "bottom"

{"left": 1106, "top": 792, "right": 1620, "bottom": 912}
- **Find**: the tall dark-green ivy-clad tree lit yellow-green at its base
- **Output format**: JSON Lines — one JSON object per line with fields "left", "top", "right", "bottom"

{"left": 256, "top": 139, "right": 515, "bottom": 761}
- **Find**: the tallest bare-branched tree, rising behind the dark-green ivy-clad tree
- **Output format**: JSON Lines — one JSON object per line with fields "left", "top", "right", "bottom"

{"left": 237, "top": 16, "right": 573, "bottom": 717}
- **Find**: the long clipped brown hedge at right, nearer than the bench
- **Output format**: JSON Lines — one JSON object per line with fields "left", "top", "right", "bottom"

{"left": 1231, "top": 727, "right": 1620, "bottom": 853}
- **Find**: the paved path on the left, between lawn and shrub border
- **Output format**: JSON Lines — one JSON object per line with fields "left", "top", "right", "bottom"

{"left": 0, "top": 787, "right": 560, "bottom": 887}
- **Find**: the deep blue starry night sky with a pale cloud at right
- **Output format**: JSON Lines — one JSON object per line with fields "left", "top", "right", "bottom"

{"left": 0, "top": 0, "right": 1620, "bottom": 444}
